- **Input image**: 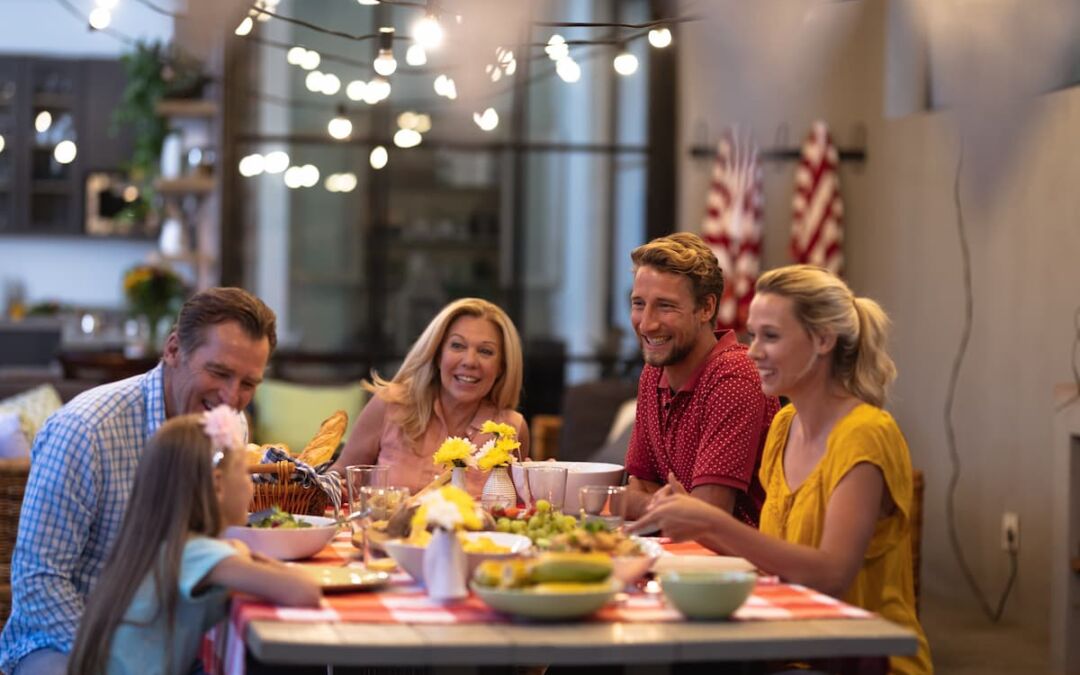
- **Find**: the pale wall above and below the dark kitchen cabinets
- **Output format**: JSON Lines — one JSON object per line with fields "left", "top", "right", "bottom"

{"left": 0, "top": 0, "right": 173, "bottom": 307}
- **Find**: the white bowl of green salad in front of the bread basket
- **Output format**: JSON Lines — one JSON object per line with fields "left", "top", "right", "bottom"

{"left": 225, "top": 507, "right": 338, "bottom": 561}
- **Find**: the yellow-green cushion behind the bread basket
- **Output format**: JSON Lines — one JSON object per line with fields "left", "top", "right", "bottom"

{"left": 253, "top": 379, "right": 367, "bottom": 453}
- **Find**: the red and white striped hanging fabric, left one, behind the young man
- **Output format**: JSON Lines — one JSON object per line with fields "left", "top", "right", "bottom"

{"left": 701, "top": 130, "right": 765, "bottom": 330}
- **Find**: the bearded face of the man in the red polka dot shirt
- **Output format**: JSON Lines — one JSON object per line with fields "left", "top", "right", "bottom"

{"left": 630, "top": 266, "right": 715, "bottom": 367}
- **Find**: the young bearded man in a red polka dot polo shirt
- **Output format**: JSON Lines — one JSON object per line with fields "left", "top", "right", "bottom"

{"left": 626, "top": 232, "right": 780, "bottom": 526}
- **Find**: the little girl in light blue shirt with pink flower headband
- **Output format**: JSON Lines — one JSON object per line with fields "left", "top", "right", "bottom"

{"left": 68, "top": 405, "right": 322, "bottom": 675}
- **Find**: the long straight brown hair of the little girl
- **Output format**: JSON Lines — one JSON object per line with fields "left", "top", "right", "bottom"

{"left": 68, "top": 415, "right": 234, "bottom": 675}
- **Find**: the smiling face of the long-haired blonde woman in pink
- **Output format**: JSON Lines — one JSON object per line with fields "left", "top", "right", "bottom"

{"left": 438, "top": 315, "right": 502, "bottom": 404}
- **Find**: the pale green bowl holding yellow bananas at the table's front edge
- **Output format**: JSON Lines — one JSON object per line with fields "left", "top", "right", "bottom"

{"left": 469, "top": 553, "right": 623, "bottom": 621}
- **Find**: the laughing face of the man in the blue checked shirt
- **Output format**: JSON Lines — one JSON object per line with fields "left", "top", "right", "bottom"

{"left": 162, "top": 321, "right": 270, "bottom": 417}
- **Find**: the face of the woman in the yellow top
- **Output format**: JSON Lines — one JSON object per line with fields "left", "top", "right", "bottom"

{"left": 746, "top": 293, "right": 832, "bottom": 396}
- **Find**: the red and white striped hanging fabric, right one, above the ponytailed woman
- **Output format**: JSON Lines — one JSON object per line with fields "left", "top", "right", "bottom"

{"left": 791, "top": 121, "right": 843, "bottom": 274}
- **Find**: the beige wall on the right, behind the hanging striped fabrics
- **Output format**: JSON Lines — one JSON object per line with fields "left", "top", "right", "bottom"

{"left": 678, "top": 0, "right": 1080, "bottom": 642}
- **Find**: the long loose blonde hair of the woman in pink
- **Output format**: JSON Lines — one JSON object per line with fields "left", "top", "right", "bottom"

{"left": 364, "top": 298, "right": 523, "bottom": 442}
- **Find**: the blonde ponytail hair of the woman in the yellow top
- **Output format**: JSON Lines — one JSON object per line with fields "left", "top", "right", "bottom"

{"left": 756, "top": 265, "right": 896, "bottom": 407}
